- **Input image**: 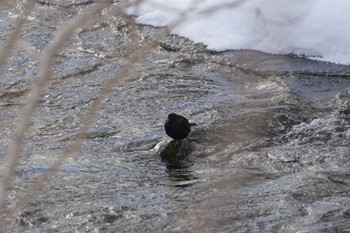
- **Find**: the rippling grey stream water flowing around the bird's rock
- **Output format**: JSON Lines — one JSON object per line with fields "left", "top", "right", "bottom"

{"left": 0, "top": 1, "right": 350, "bottom": 232}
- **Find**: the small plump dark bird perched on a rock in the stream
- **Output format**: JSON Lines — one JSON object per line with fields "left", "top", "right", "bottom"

{"left": 164, "top": 113, "right": 196, "bottom": 141}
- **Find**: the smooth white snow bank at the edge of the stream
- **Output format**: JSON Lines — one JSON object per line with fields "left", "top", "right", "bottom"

{"left": 128, "top": 0, "right": 350, "bottom": 64}
